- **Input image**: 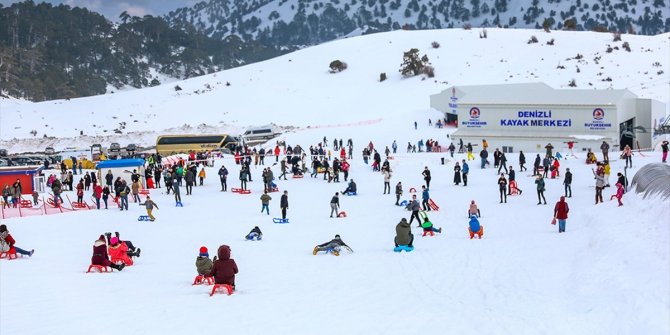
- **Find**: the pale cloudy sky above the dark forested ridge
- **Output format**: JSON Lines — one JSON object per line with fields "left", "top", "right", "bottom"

{"left": 0, "top": 0, "right": 199, "bottom": 21}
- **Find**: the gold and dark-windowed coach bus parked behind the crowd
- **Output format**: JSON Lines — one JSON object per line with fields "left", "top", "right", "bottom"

{"left": 156, "top": 134, "right": 239, "bottom": 156}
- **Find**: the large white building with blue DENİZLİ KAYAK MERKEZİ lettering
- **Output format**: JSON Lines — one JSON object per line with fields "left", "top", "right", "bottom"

{"left": 430, "top": 83, "right": 666, "bottom": 152}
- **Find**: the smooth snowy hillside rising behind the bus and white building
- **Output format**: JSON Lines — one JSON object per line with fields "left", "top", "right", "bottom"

{"left": 0, "top": 29, "right": 670, "bottom": 153}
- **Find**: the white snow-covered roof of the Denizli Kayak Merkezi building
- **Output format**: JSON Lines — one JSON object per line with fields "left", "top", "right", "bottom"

{"left": 439, "top": 82, "right": 636, "bottom": 105}
